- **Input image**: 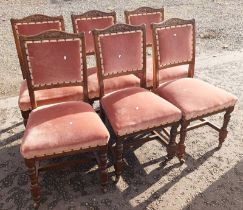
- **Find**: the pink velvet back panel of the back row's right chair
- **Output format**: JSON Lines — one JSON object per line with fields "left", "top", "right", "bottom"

{"left": 129, "top": 13, "right": 162, "bottom": 44}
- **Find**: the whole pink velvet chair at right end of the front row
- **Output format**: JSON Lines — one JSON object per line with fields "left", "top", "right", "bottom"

{"left": 152, "top": 18, "right": 237, "bottom": 163}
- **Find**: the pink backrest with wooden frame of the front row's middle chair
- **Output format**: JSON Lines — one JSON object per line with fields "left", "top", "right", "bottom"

{"left": 93, "top": 24, "right": 146, "bottom": 97}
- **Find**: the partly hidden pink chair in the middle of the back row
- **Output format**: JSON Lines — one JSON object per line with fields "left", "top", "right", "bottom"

{"left": 71, "top": 10, "right": 139, "bottom": 101}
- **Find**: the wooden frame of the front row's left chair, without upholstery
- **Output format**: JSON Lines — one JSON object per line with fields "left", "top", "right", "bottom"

{"left": 20, "top": 30, "right": 108, "bottom": 208}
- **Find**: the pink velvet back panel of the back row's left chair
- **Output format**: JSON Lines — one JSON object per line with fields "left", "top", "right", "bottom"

{"left": 16, "top": 22, "right": 61, "bottom": 36}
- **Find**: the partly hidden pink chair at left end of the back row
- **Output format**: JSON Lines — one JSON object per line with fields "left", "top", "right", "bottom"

{"left": 10, "top": 14, "right": 65, "bottom": 125}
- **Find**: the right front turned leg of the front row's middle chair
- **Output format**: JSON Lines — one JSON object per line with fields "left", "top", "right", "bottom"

{"left": 167, "top": 122, "right": 179, "bottom": 160}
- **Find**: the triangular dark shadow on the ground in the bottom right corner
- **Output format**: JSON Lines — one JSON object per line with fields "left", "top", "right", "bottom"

{"left": 183, "top": 159, "right": 243, "bottom": 210}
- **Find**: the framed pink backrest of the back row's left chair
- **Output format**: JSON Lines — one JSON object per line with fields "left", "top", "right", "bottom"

{"left": 10, "top": 14, "right": 65, "bottom": 79}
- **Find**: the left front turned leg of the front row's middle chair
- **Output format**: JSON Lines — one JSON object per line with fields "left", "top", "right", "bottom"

{"left": 115, "top": 138, "right": 123, "bottom": 182}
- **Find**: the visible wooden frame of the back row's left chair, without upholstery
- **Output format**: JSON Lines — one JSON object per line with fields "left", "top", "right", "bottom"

{"left": 10, "top": 14, "right": 65, "bottom": 126}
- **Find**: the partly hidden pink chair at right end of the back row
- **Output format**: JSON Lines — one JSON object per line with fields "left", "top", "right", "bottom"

{"left": 124, "top": 7, "right": 188, "bottom": 89}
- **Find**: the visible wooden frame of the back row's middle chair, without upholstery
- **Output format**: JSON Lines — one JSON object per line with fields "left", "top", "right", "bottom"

{"left": 71, "top": 10, "right": 116, "bottom": 55}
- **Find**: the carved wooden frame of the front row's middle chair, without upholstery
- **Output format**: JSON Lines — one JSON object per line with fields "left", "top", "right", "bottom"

{"left": 93, "top": 24, "right": 179, "bottom": 182}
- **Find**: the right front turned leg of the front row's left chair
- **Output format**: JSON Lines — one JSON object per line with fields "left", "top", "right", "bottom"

{"left": 99, "top": 146, "right": 108, "bottom": 192}
